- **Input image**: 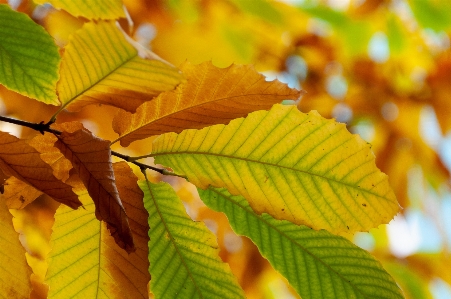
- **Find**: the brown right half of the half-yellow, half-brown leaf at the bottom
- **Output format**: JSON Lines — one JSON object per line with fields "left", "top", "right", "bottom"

{"left": 107, "top": 162, "right": 150, "bottom": 298}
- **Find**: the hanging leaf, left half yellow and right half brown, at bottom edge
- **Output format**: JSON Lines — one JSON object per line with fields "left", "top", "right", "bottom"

{"left": 46, "top": 163, "right": 150, "bottom": 299}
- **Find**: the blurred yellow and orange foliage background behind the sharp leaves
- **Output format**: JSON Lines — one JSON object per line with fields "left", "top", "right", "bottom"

{"left": 0, "top": 0, "right": 451, "bottom": 299}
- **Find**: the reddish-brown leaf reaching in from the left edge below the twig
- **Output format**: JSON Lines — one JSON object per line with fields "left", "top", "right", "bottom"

{"left": 0, "top": 132, "right": 81, "bottom": 209}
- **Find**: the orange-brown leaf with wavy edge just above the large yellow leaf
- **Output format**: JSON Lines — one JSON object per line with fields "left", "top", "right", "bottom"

{"left": 113, "top": 62, "right": 301, "bottom": 146}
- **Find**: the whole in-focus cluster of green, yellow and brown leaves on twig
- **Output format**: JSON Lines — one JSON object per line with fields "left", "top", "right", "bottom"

{"left": 0, "top": 1, "right": 403, "bottom": 298}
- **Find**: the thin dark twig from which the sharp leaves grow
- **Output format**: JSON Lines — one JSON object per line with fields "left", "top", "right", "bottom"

{"left": 0, "top": 115, "right": 186, "bottom": 179}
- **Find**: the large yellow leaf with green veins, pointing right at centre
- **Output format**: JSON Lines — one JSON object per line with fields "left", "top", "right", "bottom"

{"left": 151, "top": 105, "right": 399, "bottom": 233}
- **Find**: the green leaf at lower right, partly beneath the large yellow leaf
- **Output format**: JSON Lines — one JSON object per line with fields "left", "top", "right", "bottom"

{"left": 198, "top": 188, "right": 404, "bottom": 299}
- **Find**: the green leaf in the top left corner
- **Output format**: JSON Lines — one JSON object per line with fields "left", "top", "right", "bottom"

{"left": 0, "top": 4, "right": 60, "bottom": 105}
